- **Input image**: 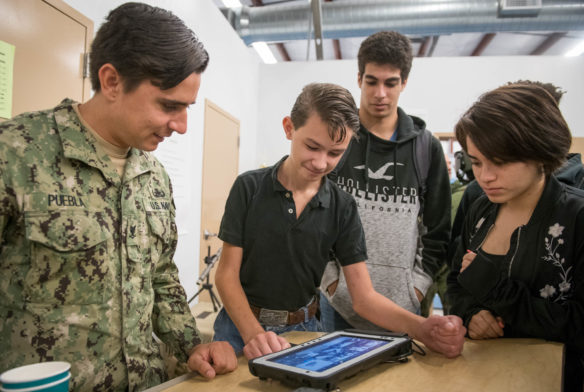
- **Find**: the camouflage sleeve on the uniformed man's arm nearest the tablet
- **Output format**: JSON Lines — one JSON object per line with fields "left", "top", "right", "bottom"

{"left": 152, "top": 179, "right": 201, "bottom": 362}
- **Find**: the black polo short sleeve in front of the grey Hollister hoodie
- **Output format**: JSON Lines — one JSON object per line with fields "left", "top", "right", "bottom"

{"left": 333, "top": 194, "right": 367, "bottom": 266}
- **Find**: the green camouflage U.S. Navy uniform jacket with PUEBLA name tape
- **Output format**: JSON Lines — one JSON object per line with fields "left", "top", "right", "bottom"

{"left": 0, "top": 100, "right": 200, "bottom": 391}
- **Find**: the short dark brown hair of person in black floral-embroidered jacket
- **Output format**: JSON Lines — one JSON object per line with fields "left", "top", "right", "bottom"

{"left": 455, "top": 83, "right": 572, "bottom": 176}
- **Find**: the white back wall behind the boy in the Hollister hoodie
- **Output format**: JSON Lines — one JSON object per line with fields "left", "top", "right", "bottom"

{"left": 256, "top": 56, "right": 584, "bottom": 165}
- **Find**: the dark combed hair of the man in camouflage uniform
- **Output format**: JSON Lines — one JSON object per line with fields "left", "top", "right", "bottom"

{"left": 90, "top": 3, "right": 209, "bottom": 92}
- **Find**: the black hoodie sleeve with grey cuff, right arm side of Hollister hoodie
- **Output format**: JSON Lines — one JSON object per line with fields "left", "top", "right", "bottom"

{"left": 413, "top": 137, "right": 451, "bottom": 294}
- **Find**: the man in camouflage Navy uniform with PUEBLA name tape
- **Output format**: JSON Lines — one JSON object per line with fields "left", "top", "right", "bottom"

{"left": 0, "top": 3, "right": 237, "bottom": 391}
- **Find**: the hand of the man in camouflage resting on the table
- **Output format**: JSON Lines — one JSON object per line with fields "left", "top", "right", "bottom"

{"left": 187, "top": 342, "right": 237, "bottom": 378}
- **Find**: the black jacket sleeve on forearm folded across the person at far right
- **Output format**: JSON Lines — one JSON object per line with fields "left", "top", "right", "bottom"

{"left": 458, "top": 212, "right": 584, "bottom": 352}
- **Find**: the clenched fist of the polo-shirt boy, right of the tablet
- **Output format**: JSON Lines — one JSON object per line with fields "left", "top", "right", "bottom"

{"left": 415, "top": 316, "right": 466, "bottom": 358}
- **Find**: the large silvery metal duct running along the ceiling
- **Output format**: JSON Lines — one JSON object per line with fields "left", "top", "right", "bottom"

{"left": 228, "top": 0, "right": 584, "bottom": 45}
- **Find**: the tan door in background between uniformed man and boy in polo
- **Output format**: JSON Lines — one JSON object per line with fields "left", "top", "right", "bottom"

{"left": 199, "top": 99, "right": 239, "bottom": 302}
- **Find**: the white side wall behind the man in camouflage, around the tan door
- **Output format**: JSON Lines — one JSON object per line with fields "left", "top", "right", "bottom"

{"left": 65, "top": 0, "right": 259, "bottom": 297}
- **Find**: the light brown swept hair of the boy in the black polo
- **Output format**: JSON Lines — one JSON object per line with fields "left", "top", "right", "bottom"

{"left": 290, "top": 83, "right": 359, "bottom": 142}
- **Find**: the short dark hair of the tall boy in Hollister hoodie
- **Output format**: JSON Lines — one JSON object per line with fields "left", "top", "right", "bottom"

{"left": 357, "top": 31, "right": 413, "bottom": 82}
